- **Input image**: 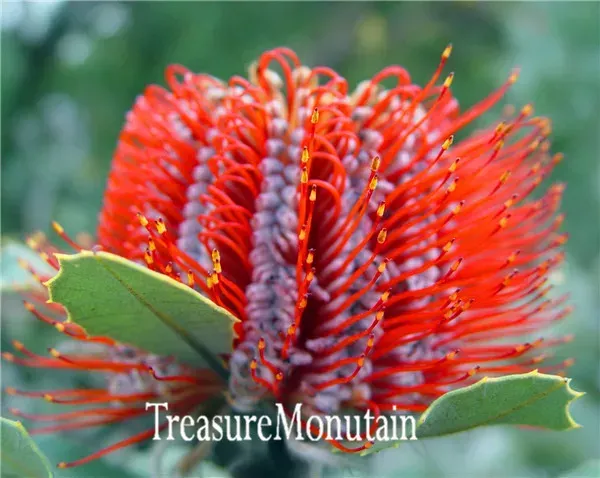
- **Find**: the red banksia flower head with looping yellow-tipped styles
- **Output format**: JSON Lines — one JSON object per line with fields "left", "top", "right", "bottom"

{"left": 5, "top": 47, "right": 569, "bottom": 466}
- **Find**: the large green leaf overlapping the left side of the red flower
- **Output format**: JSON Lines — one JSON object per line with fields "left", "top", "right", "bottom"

{"left": 47, "top": 251, "right": 238, "bottom": 378}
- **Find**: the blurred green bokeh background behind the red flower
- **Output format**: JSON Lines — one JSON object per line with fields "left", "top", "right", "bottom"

{"left": 1, "top": 1, "right": 600, "bottom": 478}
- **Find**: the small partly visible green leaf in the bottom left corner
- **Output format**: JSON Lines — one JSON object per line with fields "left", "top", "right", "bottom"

{"left": 0, "top": 417, "right": 52, "bottom": 478}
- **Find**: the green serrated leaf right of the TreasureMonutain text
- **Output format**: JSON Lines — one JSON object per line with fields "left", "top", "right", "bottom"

{"left": 363, "top": 370, "right": 584, "bottom": 455}
